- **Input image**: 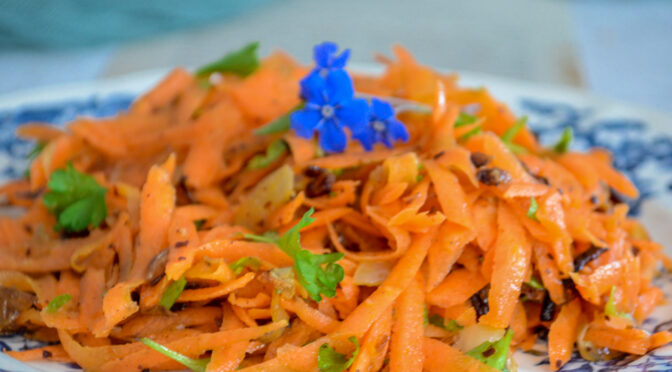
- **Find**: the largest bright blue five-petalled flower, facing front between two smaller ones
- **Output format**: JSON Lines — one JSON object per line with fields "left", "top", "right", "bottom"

{"left": 290, "top": 69, "right": 369, "bottom": 152}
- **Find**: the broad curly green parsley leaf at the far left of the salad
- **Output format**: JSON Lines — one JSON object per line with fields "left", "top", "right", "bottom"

{"left": 42, "top": 163, "right": 107, "bottom": 232}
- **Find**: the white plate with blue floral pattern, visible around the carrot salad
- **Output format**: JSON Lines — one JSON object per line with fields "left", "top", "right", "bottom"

{"left": 0, "top": 64, "right": 672, "bottom": 372}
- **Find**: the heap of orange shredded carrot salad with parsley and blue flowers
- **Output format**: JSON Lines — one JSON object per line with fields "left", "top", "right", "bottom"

{"left": 0, "top": 42, "right": 672, "bottom": 372}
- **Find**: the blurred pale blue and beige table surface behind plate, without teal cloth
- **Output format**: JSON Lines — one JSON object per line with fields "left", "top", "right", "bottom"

{"left": 0, "top": 0, "right": 672, "bottom": 112}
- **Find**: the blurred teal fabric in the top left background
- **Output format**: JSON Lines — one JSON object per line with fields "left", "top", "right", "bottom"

{"left": 0, "top": 0, "right": 269, "bottom": 51}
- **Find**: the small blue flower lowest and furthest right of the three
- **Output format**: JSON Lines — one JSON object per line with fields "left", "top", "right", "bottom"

{"left": 352, "top": 98, "right": 409, "bottom": 151}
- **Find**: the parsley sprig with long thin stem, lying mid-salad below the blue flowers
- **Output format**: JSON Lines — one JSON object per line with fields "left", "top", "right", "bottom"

{"left": 245, "top": 208, "right": 345, "bottom": 302}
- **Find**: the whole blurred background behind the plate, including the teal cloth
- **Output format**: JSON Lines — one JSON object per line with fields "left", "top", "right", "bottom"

{"left": 0, "top": 0, "right": 672, "bottom": 112}
